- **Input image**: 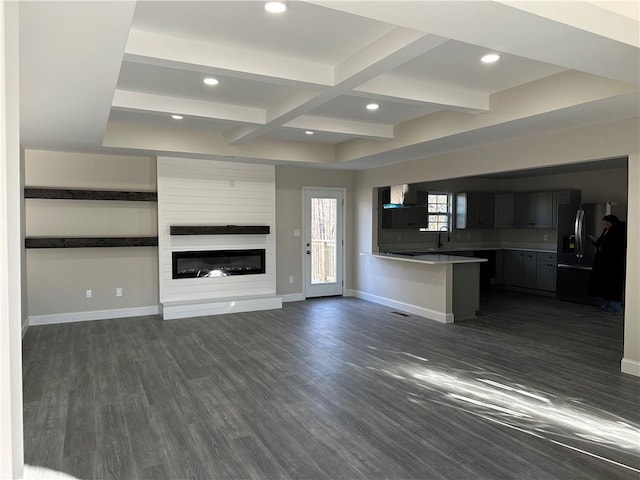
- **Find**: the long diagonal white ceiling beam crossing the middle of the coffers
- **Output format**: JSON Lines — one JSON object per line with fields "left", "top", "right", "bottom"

{"left": 229, "top": 29, "right": 446, "bottom": 143}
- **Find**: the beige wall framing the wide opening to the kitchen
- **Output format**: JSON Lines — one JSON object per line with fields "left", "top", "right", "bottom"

{"left": 354, "top": 118, "right": 640, "bottom": 375}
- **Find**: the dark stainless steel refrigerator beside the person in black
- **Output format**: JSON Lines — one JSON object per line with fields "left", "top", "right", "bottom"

{"left": 556, "top": 202, "right": 626, "bottom": 305}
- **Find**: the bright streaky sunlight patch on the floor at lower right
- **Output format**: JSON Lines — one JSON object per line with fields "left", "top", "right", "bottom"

{"left": 365, "top": 347, "right": 640, "bottom": 473}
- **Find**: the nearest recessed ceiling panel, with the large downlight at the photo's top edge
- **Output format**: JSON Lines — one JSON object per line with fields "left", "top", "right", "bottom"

{"left": 132, "top": 1, "right": 394, "bottom": 64}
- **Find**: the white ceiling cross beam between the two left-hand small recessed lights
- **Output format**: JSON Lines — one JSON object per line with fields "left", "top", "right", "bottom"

{"left": 112, "top": 90, "right": 265, "bottom": 124}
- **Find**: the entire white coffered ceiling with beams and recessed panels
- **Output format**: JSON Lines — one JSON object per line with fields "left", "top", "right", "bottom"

{"left": 19, "top": 1, "right": 640, "bottom": 169}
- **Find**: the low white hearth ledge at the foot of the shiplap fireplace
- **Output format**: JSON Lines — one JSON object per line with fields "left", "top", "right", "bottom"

{"left": 162, "top": 295, "right": 282, "bottom": 320}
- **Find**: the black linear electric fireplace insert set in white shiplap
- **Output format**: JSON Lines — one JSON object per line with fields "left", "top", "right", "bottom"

{"left": 172, "top": 249, "right": 265, "bottom": 278}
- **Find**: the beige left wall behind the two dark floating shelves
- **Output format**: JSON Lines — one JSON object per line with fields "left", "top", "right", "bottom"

{"left": 24, "top": 150, "right": 158, "bottom": 324}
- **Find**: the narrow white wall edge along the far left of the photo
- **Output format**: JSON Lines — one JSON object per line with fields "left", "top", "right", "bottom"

{"left": 0, "top": 2, "right": 24, "bottom": 478}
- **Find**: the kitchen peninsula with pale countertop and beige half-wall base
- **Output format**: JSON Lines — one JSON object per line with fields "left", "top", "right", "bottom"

{"left": 362, "top": 253, "right": 487, "bottom": 323}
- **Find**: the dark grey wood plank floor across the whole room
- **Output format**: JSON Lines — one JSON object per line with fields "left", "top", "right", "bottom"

{"left": 24, "top": 293, "right": 640, "bottom": 480}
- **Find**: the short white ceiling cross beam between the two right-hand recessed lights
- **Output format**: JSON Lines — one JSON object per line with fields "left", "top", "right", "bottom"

{"left": 355, "top": 74, "right": 489, "bottom": 114}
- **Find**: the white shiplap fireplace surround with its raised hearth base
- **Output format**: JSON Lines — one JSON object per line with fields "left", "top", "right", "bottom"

{"left": 157, "top": 157, "right": 282, "bottom": 320}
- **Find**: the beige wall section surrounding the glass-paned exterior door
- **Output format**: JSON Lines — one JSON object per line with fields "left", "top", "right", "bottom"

{"left": 276, "top": 166, "right": 354, "bottom": 298}
